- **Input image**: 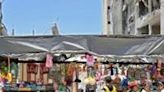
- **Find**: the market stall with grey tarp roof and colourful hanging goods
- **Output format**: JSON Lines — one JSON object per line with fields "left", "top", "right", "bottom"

{"left": 0, "top": 35, "right": 164, "bottom": 92}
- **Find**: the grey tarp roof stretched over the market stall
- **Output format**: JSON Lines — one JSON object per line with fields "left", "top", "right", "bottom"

{"left": 0, "top": 35, "right": 164, "bottom": 55}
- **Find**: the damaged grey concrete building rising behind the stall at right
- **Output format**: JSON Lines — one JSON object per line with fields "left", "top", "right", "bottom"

{"left": 103, "top": 0, "right": 164, "bottom": 35}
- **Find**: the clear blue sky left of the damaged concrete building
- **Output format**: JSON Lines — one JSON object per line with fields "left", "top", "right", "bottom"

{"left": 3, "top": 0, "right": 102, "bottom": 35}
